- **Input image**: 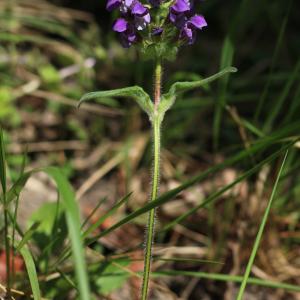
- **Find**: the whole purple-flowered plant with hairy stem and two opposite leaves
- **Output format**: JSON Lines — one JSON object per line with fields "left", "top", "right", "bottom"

{"left": 80, "top": 0, "right": 236, "bottom": 300}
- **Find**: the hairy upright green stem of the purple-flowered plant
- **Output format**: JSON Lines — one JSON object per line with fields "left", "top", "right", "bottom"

{"left": 141, "top": 61, "right": 162, "bottom": 300}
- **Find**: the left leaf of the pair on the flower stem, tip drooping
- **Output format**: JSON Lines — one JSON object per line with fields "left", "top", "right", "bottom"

{"left": 79, "top": 86, "right": 153, "bottom": 116}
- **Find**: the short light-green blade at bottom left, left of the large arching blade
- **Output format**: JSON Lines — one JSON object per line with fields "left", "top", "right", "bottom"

{"left": 20, "top": 246, "right": 41, "bottom": 300}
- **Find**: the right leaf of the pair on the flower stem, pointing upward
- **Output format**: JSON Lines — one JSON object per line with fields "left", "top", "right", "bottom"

{"left": 159, "top": 67, "right": 237, "bottom": 116}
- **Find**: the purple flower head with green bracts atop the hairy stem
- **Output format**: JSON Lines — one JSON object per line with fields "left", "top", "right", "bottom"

{"left": 106, "top": 0, "right": 207, "bottom": 51}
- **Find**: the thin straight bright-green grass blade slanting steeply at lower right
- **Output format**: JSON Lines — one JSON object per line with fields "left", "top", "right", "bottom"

{"left": 237, "top": 150, "right": 288, "bottom": 300}
